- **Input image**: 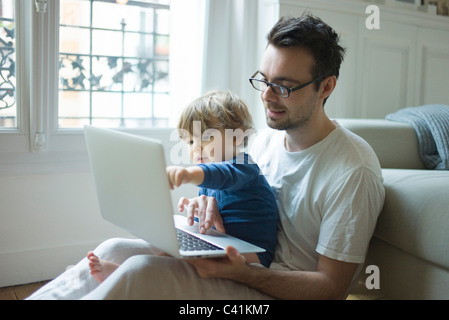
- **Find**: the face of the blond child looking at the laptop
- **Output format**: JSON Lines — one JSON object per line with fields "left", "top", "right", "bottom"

{"left": 184, "top": 129, "right": 235, "bottom": 164}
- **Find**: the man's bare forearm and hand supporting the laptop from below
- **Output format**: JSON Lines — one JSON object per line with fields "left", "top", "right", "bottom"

{"left": 189, "top": 247, "right": 358, "bottom": 299}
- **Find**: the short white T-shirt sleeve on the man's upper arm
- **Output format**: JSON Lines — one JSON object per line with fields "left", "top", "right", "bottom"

{"left": 316, "top": 168, "right": 385, "bottom": 263}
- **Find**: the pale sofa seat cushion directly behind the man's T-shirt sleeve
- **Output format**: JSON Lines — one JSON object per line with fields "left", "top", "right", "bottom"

{"left": 374, "top": 169, "right": 449, "bottom": 268}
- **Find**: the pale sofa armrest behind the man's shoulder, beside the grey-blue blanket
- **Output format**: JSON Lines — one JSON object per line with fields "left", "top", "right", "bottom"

{"left": 336, "top": 119, "right": 426, "bottom": 169}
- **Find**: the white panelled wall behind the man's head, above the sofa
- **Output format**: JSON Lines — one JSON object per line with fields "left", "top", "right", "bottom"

{"left": 274, "top": 0, "right": 449, "bottom": 118}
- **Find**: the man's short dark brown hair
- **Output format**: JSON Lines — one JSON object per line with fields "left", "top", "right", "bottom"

{"left": 267, "top": 14, "right": 346, "bottom": 99}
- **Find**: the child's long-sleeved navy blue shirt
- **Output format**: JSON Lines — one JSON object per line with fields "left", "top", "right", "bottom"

{"left": 199, "top": 153, "right": 278, "bottom": 267}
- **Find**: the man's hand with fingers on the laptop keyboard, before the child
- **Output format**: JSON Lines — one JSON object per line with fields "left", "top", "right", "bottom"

{"left": 178, "top": 195, "right": 225, "bottom": 233}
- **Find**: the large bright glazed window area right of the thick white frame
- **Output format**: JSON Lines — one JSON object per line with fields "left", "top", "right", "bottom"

{"left": 59, "top": 0, "right": 170, "bottom": 128}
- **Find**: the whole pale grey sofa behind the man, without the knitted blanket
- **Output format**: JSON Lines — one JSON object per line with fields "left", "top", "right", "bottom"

{"left": 337, "top": 119, "right": 449, "bottom": 299}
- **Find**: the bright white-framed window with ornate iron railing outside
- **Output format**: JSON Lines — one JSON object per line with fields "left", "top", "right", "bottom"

{"left": 0, "top": 0, "right": 205, "bottom": 171}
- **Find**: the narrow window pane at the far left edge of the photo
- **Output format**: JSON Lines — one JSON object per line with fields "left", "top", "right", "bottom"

{"left": 0, "top": 0, "right": 17, "bottom": 129}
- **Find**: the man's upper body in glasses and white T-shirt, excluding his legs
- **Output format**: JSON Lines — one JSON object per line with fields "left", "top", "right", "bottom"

{"left": 184, "top": 16, "right": 384, "bottom": 299}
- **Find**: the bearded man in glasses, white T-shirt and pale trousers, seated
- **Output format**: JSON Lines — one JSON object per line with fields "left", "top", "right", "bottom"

{"left": 32, "top": 16, "right": 384, "bottom": 299}
